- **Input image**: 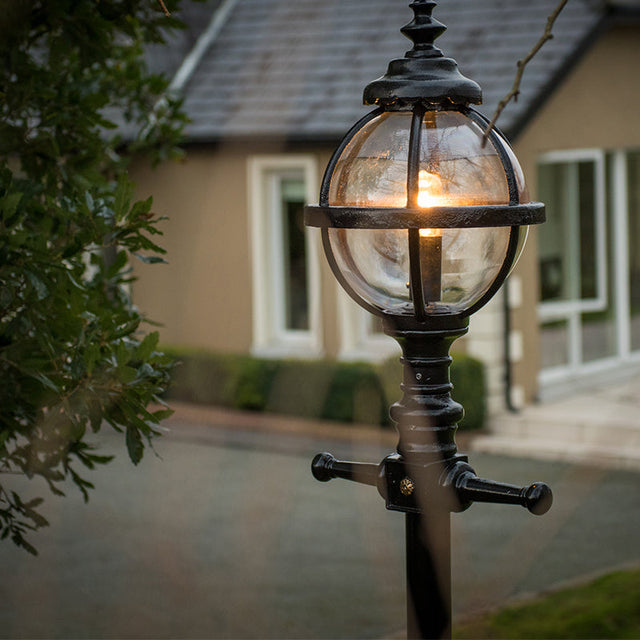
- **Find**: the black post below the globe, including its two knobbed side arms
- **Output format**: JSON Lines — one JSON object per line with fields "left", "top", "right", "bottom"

{"left": 312, "top": 316, "right": 553, "bottom": 640}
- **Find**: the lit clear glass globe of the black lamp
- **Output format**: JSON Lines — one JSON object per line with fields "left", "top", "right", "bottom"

{"left": 324, "top": 111, "right": 528, "bottom": 314}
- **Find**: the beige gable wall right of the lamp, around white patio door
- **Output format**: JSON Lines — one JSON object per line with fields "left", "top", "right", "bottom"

{"left": 514, "top": 27, "right": 640, "bottom": 400}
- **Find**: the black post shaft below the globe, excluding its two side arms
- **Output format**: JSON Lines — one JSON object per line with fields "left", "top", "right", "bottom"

{"left": 385, "top": 318, "right": 467, "bottom": 640}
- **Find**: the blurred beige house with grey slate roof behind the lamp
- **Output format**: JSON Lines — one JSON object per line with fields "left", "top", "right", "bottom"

{"left": 134, "top": 0, "right": 640, "bottom": 420}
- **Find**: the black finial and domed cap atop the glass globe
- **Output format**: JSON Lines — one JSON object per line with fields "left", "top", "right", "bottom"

{"left": 364, "top": 0, "right": 482, "bottom": 110}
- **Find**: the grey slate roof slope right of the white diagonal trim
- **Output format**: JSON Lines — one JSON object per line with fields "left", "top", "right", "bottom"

{"left": 171, "top": 0, "right": 606, "bottom": 141}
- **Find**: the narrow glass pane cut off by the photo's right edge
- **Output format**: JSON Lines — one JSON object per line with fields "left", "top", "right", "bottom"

{"left": 627, "top": 151, "right": 640, "bottom": 351}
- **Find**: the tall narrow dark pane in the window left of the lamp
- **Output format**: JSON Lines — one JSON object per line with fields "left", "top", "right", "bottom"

{"left": 280, "top": 177, "right": 309, "bottom": 331}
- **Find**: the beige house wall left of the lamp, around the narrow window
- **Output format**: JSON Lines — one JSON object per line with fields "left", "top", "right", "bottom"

{"left": 132, "top": 145, "right": 339, "bottom": 356}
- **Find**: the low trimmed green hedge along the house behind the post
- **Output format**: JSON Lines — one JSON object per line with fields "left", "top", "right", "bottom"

{"left": 163, "top": 348, "right": 486, "bottom": 429}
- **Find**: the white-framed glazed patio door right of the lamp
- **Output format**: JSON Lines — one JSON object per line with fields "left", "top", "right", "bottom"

{"left": 538, "top": 150, "right": 640, "bottom": 395}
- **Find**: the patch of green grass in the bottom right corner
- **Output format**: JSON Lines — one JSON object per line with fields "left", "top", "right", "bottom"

{"left": 453, "top": 569, "right": 640, "bottom": 640}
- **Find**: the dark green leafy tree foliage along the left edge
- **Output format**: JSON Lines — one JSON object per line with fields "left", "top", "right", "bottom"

{"left": 0, "top": 0, "right": 188, "bottom": 553}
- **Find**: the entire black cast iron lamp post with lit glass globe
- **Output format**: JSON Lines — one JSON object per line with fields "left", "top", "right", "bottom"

{"left": 305, "top": 0, "right": 552, "bottom": 638}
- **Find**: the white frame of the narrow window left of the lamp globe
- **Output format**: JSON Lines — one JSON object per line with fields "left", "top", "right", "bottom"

{"left": 247, "top": 154, "right": 323, "bottom": 357}
